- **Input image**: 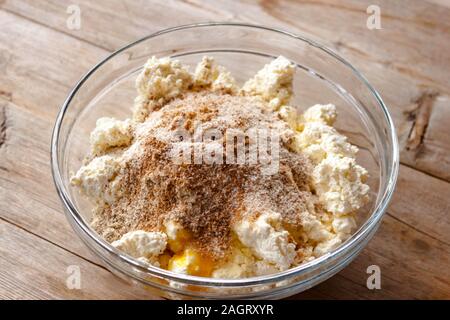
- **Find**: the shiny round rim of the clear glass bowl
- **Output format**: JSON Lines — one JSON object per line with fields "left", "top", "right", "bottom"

{"left": 50, "top": 22, "right": 399, "bottom": 287}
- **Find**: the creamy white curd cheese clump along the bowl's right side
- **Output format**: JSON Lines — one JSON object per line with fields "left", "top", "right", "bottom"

{"left": 293, "top": 104, "right": 369, "bottom": 215}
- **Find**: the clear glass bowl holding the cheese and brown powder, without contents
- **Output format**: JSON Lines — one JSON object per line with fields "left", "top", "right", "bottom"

{"left": 51, "top": 23, "right": 399, "bottom": 299}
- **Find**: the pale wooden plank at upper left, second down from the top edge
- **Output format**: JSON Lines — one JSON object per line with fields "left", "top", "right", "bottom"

{"left": 0, "top": 10, "right": 107, "bottom": 119}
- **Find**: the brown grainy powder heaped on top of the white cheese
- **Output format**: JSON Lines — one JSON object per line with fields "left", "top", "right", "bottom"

{"left": 93, "top": 93, "right": 311, "bottom": 259}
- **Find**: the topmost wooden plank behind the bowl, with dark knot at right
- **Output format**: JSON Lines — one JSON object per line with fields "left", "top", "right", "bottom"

{"left": 2, "top": 0, "right": 450, "bottom": 181}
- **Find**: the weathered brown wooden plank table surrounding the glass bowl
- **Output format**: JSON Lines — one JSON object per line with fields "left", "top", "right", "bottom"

{"left": 0, "top": 0, "right": 450, "bottom": 299}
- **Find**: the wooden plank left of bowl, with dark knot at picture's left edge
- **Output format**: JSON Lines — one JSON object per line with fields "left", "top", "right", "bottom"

{"left": 0, "top": 99, "right": 99, "bottom": 259}
